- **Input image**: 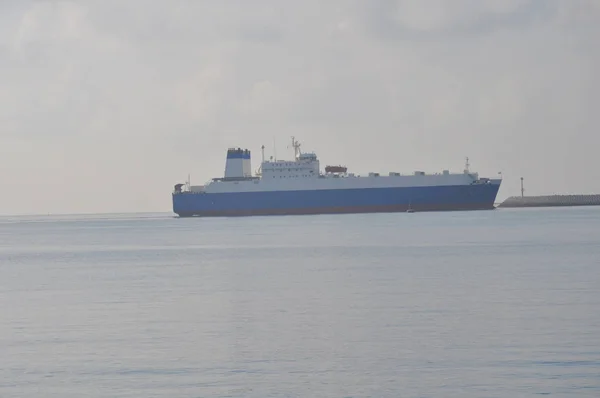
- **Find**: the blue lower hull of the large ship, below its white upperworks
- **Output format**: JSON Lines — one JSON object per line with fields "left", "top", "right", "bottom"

{"left": 173, "top": 184, "right": 500, "bottom": 217}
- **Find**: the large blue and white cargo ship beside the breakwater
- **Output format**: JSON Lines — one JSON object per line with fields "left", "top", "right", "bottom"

{"left": 172, "top": 137, "right": 502, "bottom": 217}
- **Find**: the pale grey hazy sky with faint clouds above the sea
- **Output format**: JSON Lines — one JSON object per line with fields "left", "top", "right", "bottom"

{"left": 0, "top": 0, "right": 600, "bottom": 214}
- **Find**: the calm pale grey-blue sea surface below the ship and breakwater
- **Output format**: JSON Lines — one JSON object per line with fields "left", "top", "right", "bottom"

{"left": 0, "top": 208, "right": 600, "bottom": 398}
